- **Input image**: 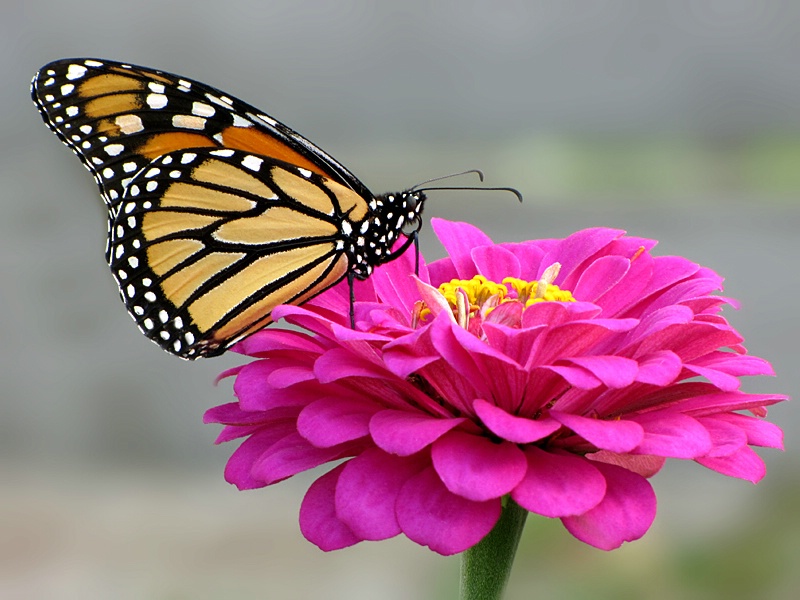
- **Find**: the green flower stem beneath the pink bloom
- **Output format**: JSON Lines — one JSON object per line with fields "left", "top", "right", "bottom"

{"left": 461, "top": 498, "right": 528, "bottom": 600}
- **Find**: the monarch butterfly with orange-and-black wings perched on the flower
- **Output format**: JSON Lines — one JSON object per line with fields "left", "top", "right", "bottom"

{"left": 31, "top": 58, "right": 519, "bottom": 360}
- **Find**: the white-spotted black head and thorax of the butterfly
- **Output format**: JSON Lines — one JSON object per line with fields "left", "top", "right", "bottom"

{"left": 350, "top": 190, "right": 426, "bottom": 279}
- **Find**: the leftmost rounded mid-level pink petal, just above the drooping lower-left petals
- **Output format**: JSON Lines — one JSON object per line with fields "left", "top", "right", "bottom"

{"left": 297, "top": 398, "right": 381, "bottom": 448}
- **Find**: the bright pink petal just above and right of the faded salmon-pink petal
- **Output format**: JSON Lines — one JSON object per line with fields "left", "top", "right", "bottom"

{"left": 631, "top": 411, "right": 711, "bottom": 459}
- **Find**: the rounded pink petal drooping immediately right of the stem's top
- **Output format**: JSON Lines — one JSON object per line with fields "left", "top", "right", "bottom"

{"left": 511, "top": 446, "right": 606, "bottom": 517}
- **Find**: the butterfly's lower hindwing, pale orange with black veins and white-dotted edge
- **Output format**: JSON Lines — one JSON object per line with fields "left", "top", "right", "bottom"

{"left": 110, "top": 148, "right": 369, "bottom": 359}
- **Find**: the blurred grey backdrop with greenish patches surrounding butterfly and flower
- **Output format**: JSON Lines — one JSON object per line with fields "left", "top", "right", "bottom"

{"left": 0, "top": 0, "right": 800, "bottom": 600}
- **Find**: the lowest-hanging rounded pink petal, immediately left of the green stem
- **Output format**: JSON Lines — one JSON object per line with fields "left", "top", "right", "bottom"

{"left": 397, "top": 467, "right": 501, "bottom": 556}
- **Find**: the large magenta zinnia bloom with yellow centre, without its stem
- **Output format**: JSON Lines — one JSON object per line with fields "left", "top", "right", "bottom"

{"left": 206, "top": 220, "right": 786, "bottom": 554}
